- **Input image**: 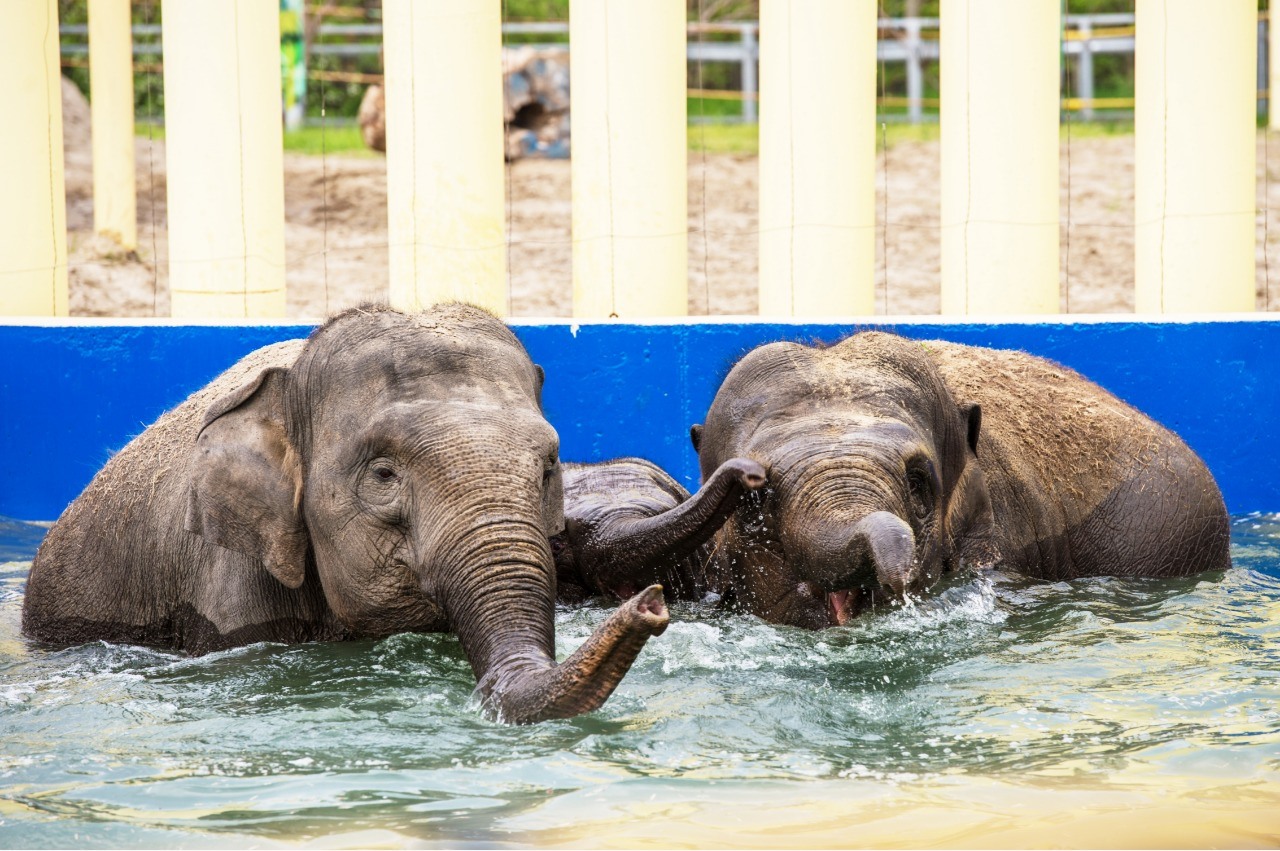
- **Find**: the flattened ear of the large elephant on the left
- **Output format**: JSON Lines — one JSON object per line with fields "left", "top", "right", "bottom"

{"left": 186, "top": 367, "right": 310, "bottom": 589}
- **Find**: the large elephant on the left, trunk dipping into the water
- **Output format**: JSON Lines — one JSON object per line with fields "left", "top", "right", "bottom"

{"left": 23, "top": 305, "right": 668, "bottom": 723}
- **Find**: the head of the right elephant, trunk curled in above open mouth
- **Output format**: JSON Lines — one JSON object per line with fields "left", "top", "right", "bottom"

{"left": 691, "top": 333, "right": 998, "bottom": 628}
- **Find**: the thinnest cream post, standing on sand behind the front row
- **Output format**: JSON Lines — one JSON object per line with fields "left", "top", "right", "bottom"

{"left": 88, "top": 0, "right": 138, "bottom": 248}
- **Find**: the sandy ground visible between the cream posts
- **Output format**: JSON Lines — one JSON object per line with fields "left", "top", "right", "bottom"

{"left": 57, "top": 83, "right": 1280, "bottom": 319}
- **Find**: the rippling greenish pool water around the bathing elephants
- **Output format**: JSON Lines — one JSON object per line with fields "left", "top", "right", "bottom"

{"left": 0, "top": 516, "right": 1280, "bottom": 847}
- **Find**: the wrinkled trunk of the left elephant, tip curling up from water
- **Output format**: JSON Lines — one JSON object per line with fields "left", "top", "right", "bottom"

{"left": 445, "top": 525, "right": 668, "bottom": 724}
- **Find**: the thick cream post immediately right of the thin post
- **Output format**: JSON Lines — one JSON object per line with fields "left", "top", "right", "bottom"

{"left": 161, "top": 0, "right": 284, "bottom": 319}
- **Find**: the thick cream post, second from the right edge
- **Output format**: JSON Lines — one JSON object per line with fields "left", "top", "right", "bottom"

{"left": 941, "top": 0, "right": 1061, "bottom": 314}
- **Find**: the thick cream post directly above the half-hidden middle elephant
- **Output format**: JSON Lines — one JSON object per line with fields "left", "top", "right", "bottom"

{"left": 570, "top": 0, "right": 689, "bottom": 319}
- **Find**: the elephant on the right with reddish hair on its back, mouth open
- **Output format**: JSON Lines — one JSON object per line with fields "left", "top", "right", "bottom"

{"left": 691, "top": 331, "right": 1230, "bottom": 628}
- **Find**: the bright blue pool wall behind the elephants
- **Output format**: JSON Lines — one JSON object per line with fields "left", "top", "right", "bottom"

{"left": 0, "top": 316, "right": 1280, "bottom": 520}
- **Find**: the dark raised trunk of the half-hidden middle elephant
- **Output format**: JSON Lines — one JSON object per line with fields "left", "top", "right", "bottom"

{"left": 591, "top": 458, "right": 765, "bottom": 587}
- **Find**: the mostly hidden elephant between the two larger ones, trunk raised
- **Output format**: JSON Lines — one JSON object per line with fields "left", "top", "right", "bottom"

{"left": 552, "top": 458, "right": 764, "bottom": 603}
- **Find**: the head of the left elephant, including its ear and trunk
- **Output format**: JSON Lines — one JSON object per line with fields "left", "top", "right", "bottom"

{"left": 187, "top": 305, "right": 667, "bottom": 723}
